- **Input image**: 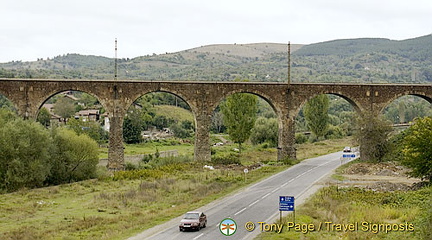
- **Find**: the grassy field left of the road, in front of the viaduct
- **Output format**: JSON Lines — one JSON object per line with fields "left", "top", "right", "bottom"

{"left": 0, "top": 136, "right": 349, "bottom": 239}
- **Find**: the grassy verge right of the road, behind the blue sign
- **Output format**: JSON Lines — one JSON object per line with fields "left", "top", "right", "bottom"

{"left": 258, "top": 166, "right": 432, "bottom": 240}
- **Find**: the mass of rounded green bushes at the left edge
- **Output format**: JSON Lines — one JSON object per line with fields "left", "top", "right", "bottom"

{"left": 0, "top": 108, "right": 98, "bottom": 192}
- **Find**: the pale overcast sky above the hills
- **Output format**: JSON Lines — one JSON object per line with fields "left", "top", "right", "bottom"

{"left": 0, "top": 0, "right": 432, "bottom": 62}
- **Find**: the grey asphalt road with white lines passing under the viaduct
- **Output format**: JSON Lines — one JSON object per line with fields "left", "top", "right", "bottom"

{"left": 129, "top": 152, "right": 354, "bottom": 240}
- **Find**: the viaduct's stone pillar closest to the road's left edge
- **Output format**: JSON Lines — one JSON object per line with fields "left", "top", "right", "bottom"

{"left": 278, "top": 113, "right": 297, "bottom": 161}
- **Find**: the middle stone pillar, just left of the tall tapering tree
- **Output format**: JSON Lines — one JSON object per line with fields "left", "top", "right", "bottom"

{"left": 194, "top": 110, "right": 211, "bottom": 161}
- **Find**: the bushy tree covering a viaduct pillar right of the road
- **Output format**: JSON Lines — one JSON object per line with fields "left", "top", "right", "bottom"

{"left": 354, "top": 112, "right": 392, "bottom": 162}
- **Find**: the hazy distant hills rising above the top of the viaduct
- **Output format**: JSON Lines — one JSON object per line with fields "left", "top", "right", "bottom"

{"left": 0, "top": 35, "right": 432, "bottom": 83}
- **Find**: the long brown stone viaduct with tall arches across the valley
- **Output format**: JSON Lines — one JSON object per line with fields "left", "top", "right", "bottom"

{"left": 0, "top": 79, "right": 432, "bottom": 169}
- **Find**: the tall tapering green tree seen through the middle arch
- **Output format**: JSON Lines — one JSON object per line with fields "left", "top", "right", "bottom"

{"left": 221, "top": 93, "right": 258, "bottom": 151}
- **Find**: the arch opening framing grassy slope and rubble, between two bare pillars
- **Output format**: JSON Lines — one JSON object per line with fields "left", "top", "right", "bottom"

{"left": 123, "top": 91, "right": 196, "bottom": 163}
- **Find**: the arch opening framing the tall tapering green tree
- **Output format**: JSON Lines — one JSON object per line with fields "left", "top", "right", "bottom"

{"left": 210, "top": 91, "right": 280, "bottom": 162}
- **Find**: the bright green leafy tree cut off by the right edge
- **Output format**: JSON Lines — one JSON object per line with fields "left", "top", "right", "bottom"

{"left": 402, "top": 117, "right": 432, "bottom": 182}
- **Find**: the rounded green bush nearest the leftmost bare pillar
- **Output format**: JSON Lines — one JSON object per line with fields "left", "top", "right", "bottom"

{"left": 47, "top": 128, "right": 99, "bottom": 184}
